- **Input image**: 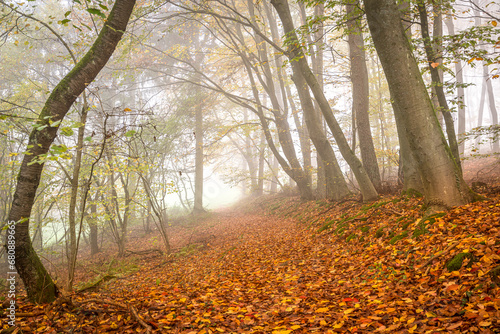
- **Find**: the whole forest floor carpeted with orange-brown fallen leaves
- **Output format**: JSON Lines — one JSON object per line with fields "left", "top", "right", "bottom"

{"left": 0, "top": 158, "right": 500, "bottom": 334}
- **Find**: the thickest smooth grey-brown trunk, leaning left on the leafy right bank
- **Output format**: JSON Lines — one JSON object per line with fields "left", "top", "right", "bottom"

{"left": 364, "top": 0, "right": 475, "bottom": 210}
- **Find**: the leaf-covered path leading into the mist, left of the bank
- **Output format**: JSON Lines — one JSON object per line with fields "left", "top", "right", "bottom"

{"left": 108, "top": 211, "right": 335, "bottom": 333}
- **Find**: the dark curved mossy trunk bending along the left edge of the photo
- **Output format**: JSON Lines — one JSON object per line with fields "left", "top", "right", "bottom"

{"left": 8, "top": 0, "right": 135, "bottom": 303}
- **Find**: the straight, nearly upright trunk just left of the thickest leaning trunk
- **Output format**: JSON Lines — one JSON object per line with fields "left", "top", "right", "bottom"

{"left": 346, "top": 0, "right": 381, "bottom": 191}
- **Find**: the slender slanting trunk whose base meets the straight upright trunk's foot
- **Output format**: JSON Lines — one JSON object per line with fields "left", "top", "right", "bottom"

{"left": 271, "top": 0, "right": 378, "bottom": 201}
